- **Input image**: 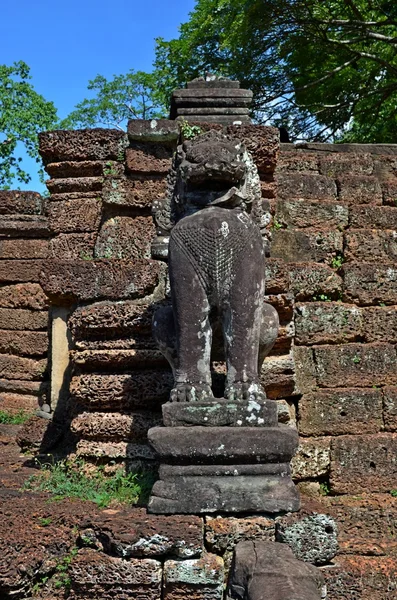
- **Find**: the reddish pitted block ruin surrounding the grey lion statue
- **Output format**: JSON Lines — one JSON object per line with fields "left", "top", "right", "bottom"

{"left": 0, "top": 77, "right": 397, "bottom": 600}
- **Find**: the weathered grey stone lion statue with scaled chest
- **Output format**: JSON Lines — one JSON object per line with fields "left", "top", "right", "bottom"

{"left": 153, "top": 130, "right": 278, "bottom": 402}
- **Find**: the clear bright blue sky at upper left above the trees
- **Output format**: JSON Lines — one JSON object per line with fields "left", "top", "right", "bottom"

{"left": 0, "top": 0, "right": 195, "bottom": 191}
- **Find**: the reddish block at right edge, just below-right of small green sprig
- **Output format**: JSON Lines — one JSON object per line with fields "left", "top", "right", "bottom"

{"left": 342, "top": 262, "right": 397, "bottom": 306}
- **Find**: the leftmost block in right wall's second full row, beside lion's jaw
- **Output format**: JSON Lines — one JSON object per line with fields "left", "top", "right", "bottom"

{"left": 276, "top": 173, "right": 337, "bottom": 201}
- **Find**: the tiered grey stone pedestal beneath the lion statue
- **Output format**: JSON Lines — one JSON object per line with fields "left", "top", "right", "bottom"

{"left": 148, "top": 400, "right": 299, "bottom": 514}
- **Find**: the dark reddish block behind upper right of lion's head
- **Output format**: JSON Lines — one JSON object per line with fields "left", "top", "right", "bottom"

{"left": 226, "top": 125, "right": 280, "bottom": 174}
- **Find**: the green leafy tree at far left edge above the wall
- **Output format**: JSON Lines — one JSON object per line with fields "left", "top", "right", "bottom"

{"left": 0, "top": 61, "right": 57, "bottom": 189}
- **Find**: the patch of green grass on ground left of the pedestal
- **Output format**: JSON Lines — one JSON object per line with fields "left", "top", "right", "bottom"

{"left": 24, "top": 460, "right": 154, "bottom": 507}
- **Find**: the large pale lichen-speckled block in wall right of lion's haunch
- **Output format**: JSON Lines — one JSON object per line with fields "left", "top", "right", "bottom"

{"left": 295, "top": 302, "right": 363, "bottom": 345}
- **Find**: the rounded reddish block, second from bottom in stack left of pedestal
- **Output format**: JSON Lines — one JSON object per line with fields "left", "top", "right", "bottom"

{"left": 70, "top": 411, "right": 162, "bottom": 443}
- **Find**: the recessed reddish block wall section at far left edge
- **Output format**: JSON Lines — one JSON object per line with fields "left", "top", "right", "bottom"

{"left": 0, "top": 191, "right": 50, "bottom": 414}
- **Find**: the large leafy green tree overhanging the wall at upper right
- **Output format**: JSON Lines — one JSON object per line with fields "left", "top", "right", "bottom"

{"left": 155, "top": 0, "right": 397, "bottom": 142}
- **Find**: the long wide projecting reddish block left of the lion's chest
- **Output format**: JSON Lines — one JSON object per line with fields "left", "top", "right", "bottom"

{"left": 39, "top": 259, "right": 164, "bottom": 302}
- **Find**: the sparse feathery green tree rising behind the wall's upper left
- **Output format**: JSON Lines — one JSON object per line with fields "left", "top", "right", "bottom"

{"left": 61, "top": 69, "right": 165, "bottom": 131}
